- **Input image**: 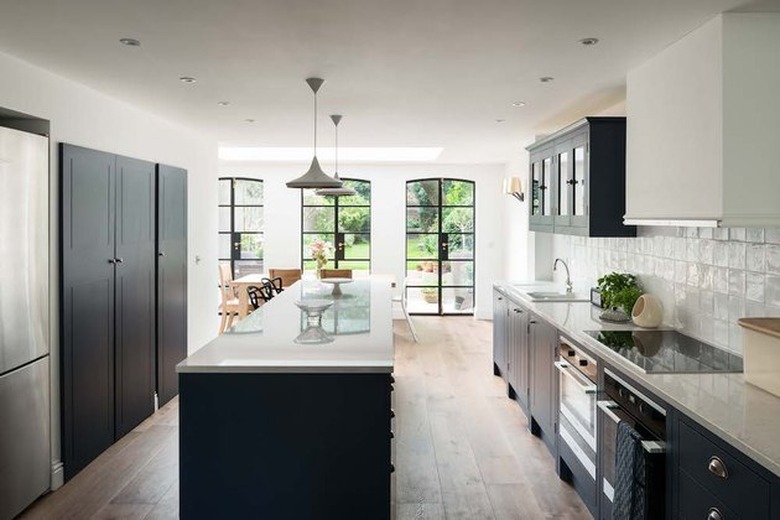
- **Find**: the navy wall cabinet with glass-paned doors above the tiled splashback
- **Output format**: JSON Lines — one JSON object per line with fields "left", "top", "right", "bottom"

{"left": 527, "top": 117, "right": 636, "bottom": 237}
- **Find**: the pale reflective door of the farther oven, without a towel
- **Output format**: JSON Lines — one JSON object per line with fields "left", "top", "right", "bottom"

{"left": 554, "top": 361, "right": 597, "bottom": 452}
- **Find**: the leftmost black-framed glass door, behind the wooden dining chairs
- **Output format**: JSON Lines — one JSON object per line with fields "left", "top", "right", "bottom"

{"left": 219, "top": 177, "right": 265, "bottom": 278}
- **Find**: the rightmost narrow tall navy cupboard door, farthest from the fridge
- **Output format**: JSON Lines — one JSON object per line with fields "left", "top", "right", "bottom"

{"left": 157, "top": 164, "right": 187, "bottom": 406}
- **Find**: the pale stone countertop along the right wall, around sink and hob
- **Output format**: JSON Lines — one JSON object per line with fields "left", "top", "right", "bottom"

{"left": 494, "top": 282, "right": 780, "bottom": 476}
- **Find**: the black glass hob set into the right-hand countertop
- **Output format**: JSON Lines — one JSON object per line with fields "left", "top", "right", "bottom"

{"left": 585, "top": 330, "right": 742, "bottom": 374}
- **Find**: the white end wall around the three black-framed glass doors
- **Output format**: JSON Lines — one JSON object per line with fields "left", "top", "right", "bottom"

{"left": 220, "top": 162, "right": 510, "bottom": 318}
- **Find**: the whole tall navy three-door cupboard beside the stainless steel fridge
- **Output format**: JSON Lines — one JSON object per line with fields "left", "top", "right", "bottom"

{"left": 60, "top": 144, "right": 186, "bottom": 479}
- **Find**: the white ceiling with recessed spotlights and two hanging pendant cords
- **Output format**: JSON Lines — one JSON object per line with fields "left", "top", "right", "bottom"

{"left": 0, "top": 0, "right": 780, "bottom": 163}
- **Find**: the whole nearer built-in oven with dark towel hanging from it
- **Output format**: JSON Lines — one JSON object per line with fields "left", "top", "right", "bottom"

{"left": 597, "top": 369, "right": 666, "bottom": 519}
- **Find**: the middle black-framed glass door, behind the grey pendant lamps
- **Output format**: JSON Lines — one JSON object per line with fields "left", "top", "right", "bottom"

{"left": 301, "top": 178, "right": 371, "bottom": 273}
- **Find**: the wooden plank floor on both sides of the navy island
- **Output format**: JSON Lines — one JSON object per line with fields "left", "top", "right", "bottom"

{"left": 21, "top": 317, "right": 590, "bottom": 520}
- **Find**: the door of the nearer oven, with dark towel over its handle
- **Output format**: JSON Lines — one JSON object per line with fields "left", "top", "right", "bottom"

{"left": 597, "top": 401, "right": 666, "bottom": 519}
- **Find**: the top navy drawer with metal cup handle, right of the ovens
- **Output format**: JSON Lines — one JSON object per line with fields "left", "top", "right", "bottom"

{"left": 679, "top": 421, "right": 770, "bottom": 519}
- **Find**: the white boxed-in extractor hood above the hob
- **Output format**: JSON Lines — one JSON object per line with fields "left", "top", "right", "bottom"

{"left": 625, "top": 13, "right": 780, "bottom": 227}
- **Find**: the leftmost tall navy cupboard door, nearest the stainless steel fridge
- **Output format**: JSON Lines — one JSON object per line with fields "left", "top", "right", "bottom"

{"left": 60, "top": 144, "right": 116, "bottom": 479}
